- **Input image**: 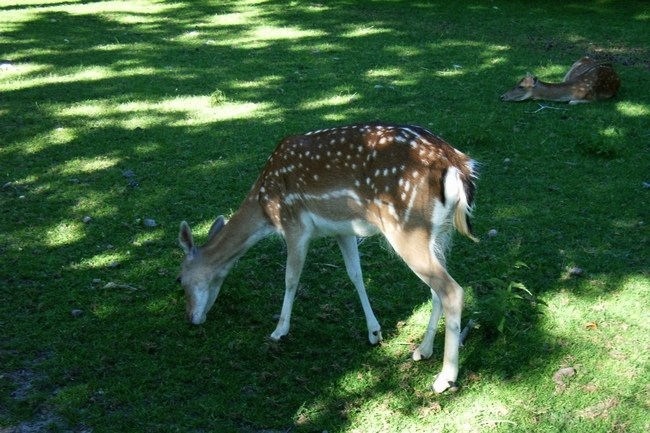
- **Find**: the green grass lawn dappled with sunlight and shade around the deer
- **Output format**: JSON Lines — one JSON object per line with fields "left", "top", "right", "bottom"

{"left": 0, "top": 0, "right": 650, "bottom": 433}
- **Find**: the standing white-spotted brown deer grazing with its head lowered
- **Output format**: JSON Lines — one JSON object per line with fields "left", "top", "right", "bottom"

{"left": 179, "top": 123, "right": 476, "bottom": 392}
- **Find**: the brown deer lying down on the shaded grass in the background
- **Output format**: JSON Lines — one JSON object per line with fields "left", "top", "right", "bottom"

{"left": 501, "top": 57, "right": 621, "bottom": 104}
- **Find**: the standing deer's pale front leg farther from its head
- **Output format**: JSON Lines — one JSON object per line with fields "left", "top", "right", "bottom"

{"left": 336, "top": 236, "right": 382, "bottom": 344}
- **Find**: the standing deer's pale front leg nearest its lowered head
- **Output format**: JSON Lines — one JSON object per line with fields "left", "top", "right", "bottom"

{"left": 271, "top": 231, "right": 309, "bottom": 341}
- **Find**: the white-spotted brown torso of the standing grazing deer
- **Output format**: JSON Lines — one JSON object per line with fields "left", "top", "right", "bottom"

{"left": 254, "top": 124, "right": 475, "bottom": 240}
